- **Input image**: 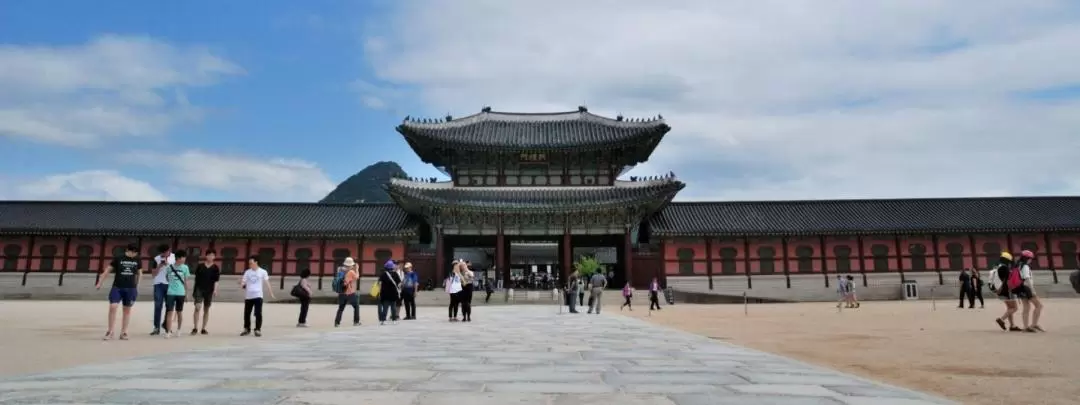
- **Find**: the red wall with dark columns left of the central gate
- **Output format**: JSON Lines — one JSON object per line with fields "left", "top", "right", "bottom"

{"left": 0, "top": 235, "right": 405, "bottom": 282}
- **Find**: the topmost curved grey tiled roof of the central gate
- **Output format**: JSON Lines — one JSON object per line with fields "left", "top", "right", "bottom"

{"left": 397, "top": 107, "right": 671, "bottom": 158}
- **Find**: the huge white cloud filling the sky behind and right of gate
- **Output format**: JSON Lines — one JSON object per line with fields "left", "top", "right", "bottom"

{"left": 364, "top": 0, "right": 1080, "bottom": 200}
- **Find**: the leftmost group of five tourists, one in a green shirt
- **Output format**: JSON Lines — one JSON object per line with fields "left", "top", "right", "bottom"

{"left": 95, "top": 244, "right": 274, "bottom": 340}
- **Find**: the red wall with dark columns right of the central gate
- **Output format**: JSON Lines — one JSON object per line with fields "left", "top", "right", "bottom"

{"left": 662, "top": 233, "right": 1080, "bottom": 276}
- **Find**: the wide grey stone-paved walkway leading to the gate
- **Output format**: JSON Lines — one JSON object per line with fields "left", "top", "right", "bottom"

{"left": 0, "top": 306, "right": 948, "bottom": 405}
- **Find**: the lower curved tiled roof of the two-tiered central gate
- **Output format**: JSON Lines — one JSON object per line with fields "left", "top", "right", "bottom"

{"left": 387, "top": 177, "right": 686, "bottom": 211}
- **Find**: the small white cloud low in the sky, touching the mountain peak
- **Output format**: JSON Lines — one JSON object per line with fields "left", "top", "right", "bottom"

{"left": 147, "top": 150, "right": 336, "bottom": 201}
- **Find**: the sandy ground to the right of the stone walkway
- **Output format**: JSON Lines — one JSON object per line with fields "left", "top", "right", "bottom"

{"left": 622, "top": 299, "right": 1080, "bottom": 404}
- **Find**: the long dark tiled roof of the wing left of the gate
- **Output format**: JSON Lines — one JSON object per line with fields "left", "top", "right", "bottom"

{"left": 0, "top": 201, "right": 418, "bottom": 238}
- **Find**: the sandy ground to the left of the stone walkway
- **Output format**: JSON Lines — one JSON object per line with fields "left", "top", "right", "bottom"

{"left": 0, "top": 301, "right": 380, "bottom": 376}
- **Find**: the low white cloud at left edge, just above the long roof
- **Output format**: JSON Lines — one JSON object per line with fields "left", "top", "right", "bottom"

{"left": 0, "top": 171, "right": 167, "bottom": 201}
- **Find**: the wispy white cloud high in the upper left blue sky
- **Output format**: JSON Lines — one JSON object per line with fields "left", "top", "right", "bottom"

{"left": 0, "top": 36, "right": 244, "bottom": 146}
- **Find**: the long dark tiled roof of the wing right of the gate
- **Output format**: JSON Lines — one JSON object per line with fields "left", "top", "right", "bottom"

{"left": 650, "top": 197, "right": 1080, "bottom": 235}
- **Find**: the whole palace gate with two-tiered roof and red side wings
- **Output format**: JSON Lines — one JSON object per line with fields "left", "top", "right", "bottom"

{"left": 0, "top": 107, "right": 1080, "bottom": 299}
